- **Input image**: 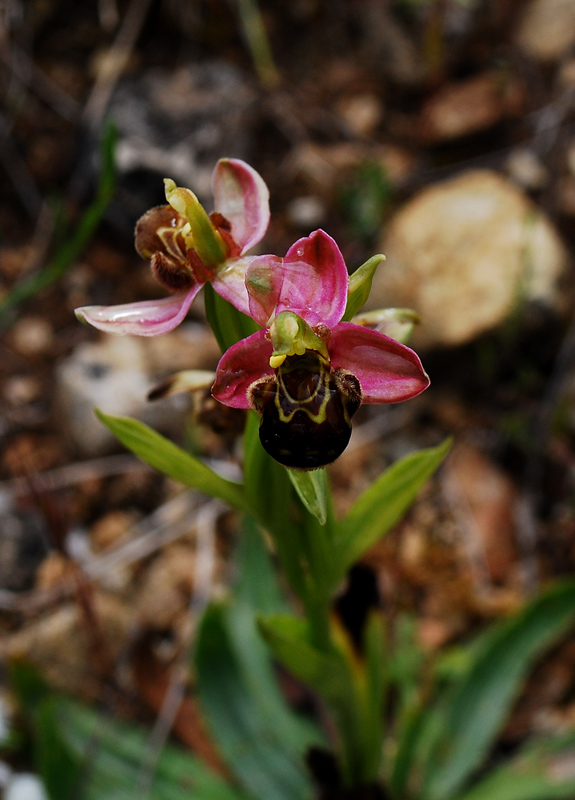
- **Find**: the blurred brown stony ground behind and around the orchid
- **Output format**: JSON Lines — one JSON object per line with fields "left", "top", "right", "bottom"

{"left": 0, "top": 0, "right": 575, "bottom": 788}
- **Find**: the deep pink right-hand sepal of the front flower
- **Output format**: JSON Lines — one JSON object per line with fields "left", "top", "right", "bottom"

{"left": 328, "top": 322, "right": 429, "bottom": 403}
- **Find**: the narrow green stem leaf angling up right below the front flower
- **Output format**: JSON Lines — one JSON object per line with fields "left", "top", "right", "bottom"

{"left": 335, "top": 439, "right": 451, "bottom": 577}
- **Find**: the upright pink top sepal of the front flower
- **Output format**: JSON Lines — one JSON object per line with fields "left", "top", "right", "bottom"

{"left": 276, "top": 230, "right": 349, "bottom": 327}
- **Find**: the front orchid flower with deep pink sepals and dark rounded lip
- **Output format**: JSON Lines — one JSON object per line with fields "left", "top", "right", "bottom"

{"left": 212, "top": 230, "right": 429, "bottom": 470}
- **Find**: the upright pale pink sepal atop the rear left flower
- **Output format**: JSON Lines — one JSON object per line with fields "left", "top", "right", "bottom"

{"left": 212, "top": 158, "right": 270, "bottom": 254}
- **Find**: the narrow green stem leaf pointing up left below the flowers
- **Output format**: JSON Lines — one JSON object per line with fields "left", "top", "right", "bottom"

{"left": 96, "top": 410, "right": 250, "bottom": 513}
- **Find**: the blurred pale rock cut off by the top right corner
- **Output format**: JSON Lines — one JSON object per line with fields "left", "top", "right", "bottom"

{"left": 515, "top": 0, "right": 575, "bottom": 61}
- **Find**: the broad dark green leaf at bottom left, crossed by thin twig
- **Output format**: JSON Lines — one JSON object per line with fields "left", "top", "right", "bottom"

{"left": 34, "top": 695, "right": 249, "bottom": 800}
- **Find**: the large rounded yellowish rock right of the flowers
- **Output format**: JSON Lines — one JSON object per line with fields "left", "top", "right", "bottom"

{"left": 368, "top": 170, "right": 567, "bottom": 348}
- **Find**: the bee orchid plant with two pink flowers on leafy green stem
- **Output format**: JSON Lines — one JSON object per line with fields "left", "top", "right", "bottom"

{"left": 76, "top": 159, "right": 449, "bottom": 800}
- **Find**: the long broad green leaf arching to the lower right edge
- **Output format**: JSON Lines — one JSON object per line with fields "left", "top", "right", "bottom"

{"left": 424, "top": 580, "right": 575, "bottom": 800}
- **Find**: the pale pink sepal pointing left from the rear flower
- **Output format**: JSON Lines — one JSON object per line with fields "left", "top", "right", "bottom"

{"left": 75, "top": 283, "right": 202, "bottom": 336}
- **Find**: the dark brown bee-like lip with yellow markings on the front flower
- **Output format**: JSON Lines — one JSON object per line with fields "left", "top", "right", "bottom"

{"left": 250, "top": 351, "right": 361, "bottom": 470}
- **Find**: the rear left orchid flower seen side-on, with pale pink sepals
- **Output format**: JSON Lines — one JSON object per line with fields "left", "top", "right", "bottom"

{"left": 76, "top": 158, "right": 270, "bottom": 336}
